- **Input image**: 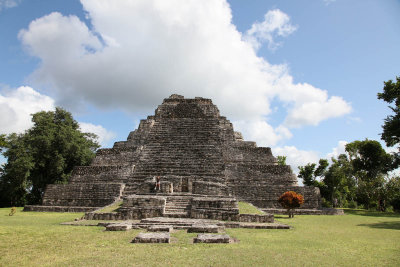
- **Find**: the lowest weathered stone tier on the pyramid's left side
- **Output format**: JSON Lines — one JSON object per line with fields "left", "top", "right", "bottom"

{"left": 42, "top": 183, "right": 123, "bottom": 207}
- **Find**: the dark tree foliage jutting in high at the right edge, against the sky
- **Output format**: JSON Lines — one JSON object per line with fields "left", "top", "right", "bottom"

{"left": 378, "top": 77, "right": 400, "bottom": 151}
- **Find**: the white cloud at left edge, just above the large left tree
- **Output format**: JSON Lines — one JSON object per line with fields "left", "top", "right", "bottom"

{"left": 0, "top": 86, "right": 55, "bottom": 134}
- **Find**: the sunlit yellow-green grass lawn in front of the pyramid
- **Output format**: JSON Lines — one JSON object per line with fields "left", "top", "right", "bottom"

{"left": 0, "top": 208, "right": 400, "bottom": 266}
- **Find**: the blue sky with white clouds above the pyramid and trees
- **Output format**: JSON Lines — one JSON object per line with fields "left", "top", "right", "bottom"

{"left": 0, "top": 0, "right": 400, "bottom": 175}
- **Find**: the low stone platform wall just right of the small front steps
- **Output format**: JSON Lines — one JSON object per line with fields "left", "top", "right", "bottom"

{"left": 190, "top": 197, "right": 239, "bottom": 221}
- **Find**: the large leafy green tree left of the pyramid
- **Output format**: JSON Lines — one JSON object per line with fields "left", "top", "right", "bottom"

{"left": 0, "top": 108, "right": 99, "bottom": 206}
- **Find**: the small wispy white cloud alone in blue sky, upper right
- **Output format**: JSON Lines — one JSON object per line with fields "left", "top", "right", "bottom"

{"left": 244, "top": 9, "right": 298, "bottom": 50}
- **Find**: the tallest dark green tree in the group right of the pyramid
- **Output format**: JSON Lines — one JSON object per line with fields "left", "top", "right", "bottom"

{"left": 346, "top": 139, "right": 395, "bottom": 209}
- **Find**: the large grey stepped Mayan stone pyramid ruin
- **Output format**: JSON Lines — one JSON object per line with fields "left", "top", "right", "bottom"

{"left": 25, "top": 95, "right": 320, "bottom": 220}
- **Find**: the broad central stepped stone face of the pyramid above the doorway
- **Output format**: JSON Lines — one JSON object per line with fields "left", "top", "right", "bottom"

{"left": 124, "top": 118, "right": 228, "bottom": 196}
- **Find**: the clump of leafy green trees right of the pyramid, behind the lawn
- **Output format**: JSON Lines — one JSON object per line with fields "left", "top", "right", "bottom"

{"left": 299, "top": 139, "right": 397, "bottom": 211}
